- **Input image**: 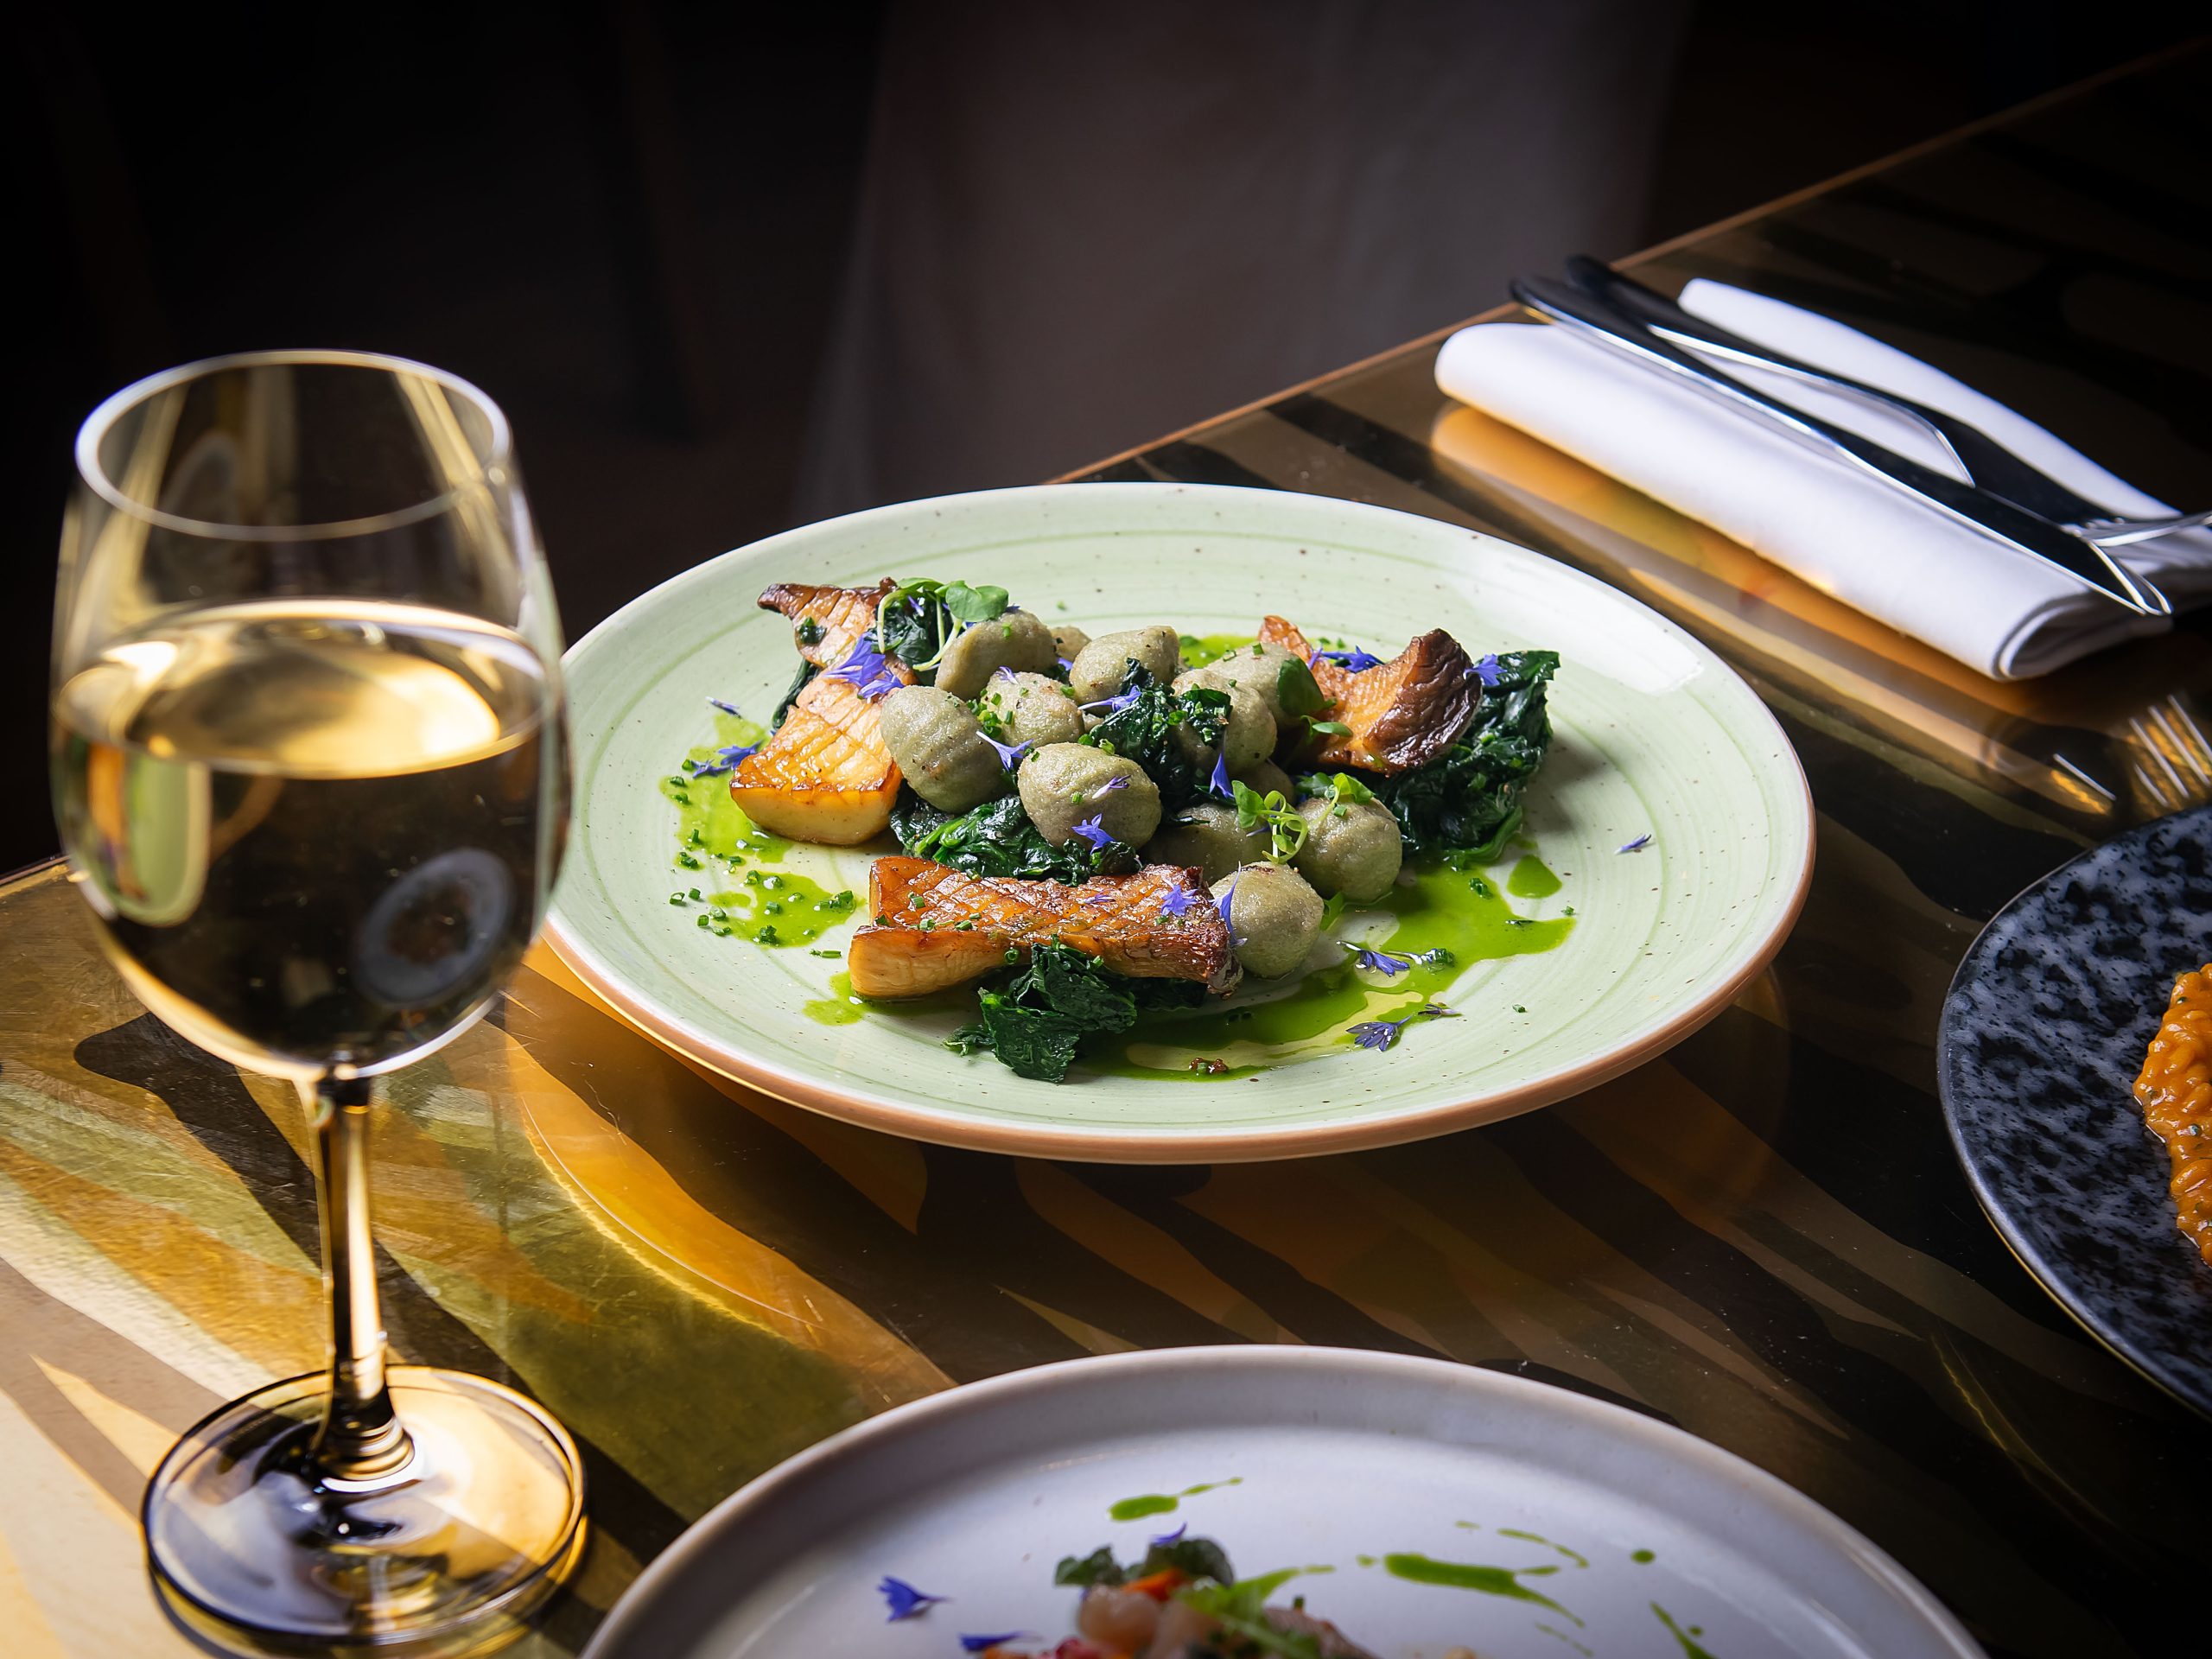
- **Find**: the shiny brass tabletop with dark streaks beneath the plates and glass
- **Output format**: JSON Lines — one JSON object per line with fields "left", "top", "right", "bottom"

{"left": 0, "top": 51, "right": 2212, "bottom": 1659}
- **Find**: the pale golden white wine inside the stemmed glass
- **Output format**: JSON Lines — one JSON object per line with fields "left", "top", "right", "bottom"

{"left": 53, "top": 600, "right": 569, "bottom": 1075}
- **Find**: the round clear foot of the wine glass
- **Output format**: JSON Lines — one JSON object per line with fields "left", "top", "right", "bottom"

{"left": 143, "top": 1365, "right": 584, "bottom": 1659}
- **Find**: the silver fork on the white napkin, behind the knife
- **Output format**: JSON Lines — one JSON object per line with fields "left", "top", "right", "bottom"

{"left": 1566, "top": 254, "right": 2212, "bottom": 546}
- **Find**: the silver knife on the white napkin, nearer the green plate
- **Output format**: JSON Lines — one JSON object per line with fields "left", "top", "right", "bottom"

{"left": 1510, "top": 276, "right": 2172, "bottom": 615}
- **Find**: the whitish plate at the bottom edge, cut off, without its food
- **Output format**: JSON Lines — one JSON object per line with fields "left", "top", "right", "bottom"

{"left": 586, "top": 1347, "right": 1980, "bottom": 1659}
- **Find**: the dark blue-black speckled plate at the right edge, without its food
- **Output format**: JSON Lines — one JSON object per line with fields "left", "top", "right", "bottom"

{"left": 1938, "top": 807, "right": 2212, "bottom": 1415}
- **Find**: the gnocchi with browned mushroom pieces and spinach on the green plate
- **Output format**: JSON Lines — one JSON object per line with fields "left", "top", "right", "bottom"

{"left": 671, "top": 577, "right": 1573, "bottom": 1082}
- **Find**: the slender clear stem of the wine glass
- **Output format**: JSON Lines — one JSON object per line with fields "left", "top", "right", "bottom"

{"left": 301, "top": 1075, "right": 414, "bottom": 1482}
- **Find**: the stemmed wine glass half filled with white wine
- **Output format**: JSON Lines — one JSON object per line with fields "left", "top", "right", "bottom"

{"left": 51, "top": 352, "right": 584, "bottom": 1655}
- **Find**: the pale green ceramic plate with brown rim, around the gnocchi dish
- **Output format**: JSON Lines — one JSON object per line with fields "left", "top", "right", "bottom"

{"left": 549, "top": 485, "right": 1812, "bottom": 1161}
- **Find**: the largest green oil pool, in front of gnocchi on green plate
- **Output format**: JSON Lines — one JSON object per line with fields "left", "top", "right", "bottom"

{"left": 1106, "top": 869, "right": 1575, "bottom": 1082}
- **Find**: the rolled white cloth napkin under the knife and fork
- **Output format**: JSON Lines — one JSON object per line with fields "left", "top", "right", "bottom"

{"left": 1435, "top": 279, "right": 2212, "bottom": 679}
